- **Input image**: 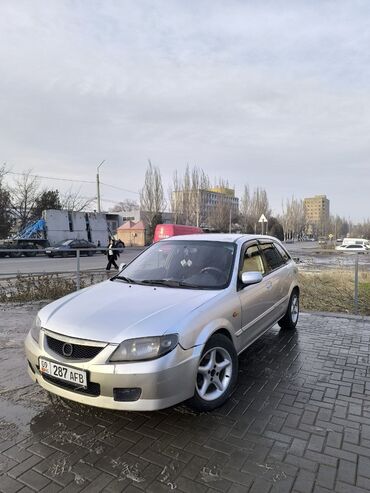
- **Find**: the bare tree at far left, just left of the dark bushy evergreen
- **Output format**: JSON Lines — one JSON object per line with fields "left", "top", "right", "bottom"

{"left": 9, "top": 170, "right": 40, "bottom": 228}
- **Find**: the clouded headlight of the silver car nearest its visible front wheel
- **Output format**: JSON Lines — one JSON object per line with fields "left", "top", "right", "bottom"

{"left": 110, "top": 334, "right": 179, "bottom": 361}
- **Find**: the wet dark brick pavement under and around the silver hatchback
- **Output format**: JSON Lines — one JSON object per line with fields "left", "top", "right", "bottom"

{"left": 0, "top": 305, "right": 370, "bottom": 493}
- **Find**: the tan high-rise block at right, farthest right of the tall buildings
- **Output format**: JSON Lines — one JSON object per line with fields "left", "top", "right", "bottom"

{"left": 303, "top": 195, "right": 330, "bottom": 236}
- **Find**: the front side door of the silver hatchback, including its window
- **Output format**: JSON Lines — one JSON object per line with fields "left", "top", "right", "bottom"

{"left": 237, "top": 241, "right": 272, "bottom": 347}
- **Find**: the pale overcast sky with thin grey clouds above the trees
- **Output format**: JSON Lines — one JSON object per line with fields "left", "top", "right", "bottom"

{"left": 0, "top": 0, "right": 370, "bottom": 221}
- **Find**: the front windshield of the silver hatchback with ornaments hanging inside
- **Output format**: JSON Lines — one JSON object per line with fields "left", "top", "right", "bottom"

{"left": 116, "top": 240, "right": 236, "bottom": 289}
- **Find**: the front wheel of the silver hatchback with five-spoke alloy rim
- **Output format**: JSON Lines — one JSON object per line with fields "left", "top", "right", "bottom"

{"left": 188, "top": 334, "right": 238, "bottom": 411}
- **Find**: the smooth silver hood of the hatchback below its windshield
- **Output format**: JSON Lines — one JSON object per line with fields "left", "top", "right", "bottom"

{"left": 39, "top": 281, "right": 219, "bottom": 344}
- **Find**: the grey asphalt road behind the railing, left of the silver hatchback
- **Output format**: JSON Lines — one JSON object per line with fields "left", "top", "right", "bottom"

{"left": 0, "top": 248, "right": 143, "bottom": 278}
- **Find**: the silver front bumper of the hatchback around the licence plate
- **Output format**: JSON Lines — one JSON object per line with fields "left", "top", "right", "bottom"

{"left": 25, "top": 330, "right": 202, "bottom": 411}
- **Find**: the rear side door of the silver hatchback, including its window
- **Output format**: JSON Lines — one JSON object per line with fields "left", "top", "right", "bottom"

{"left": 260, "top": 241, "right": 291, "bottom": 325}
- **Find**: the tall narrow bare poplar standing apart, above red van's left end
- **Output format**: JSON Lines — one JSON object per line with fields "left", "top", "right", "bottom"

{"left": 140, "top": 160, "right": 166, "bottom": 240}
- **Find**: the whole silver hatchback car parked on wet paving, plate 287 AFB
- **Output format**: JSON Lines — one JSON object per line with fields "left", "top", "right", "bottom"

{"left": 25, "top": 234, "right": 299, "bottom": 410}
